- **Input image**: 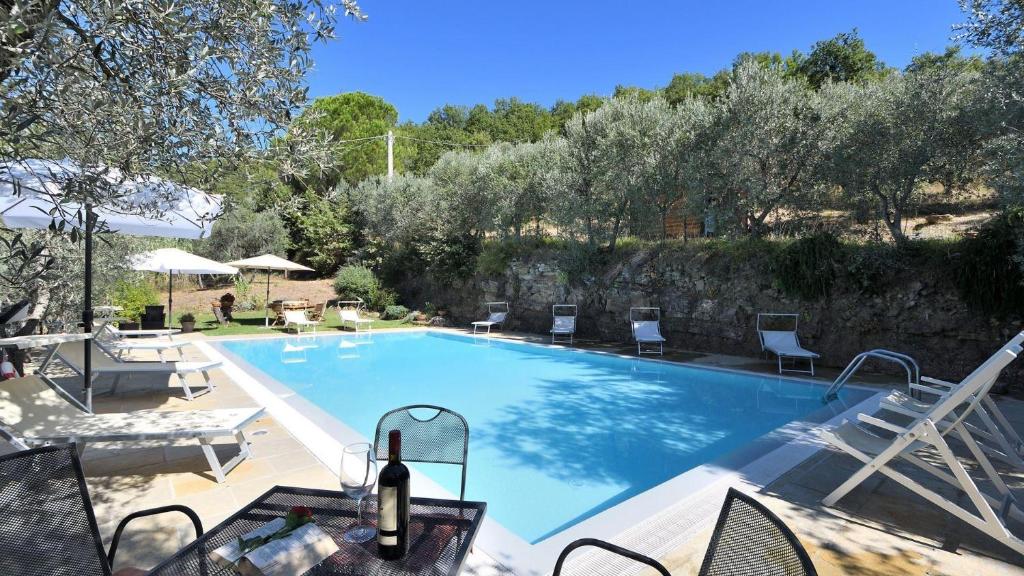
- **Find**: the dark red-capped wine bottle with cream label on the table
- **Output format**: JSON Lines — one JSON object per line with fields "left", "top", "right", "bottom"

{"left": 377, "top": 430, "right": 409, "bottom": 560}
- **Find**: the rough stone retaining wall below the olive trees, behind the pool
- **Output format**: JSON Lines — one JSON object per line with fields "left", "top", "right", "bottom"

{"left": 402, "top": 245, "right": 1021, "bottom": 379}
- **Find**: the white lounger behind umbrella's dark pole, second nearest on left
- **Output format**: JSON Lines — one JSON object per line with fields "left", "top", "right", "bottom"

{"left": 54, "top": 342, "right": 221, "bottom": 400}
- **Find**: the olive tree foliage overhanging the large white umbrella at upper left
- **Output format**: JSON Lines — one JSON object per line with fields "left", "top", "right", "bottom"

{"left": 0, "top": 0, "right": 361, "bottom": 330}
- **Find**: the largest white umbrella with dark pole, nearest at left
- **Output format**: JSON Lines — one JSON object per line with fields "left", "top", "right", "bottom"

{"left": 0, "top": 159, "right": 221, "bottom": 410}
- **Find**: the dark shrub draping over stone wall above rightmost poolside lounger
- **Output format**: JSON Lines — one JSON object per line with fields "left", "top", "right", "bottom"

{"left": 774, "top": 233, "right": 843, "bottom": 300}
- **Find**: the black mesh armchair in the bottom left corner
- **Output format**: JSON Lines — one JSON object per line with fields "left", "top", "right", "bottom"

{"left": 0, "top": 444, "right": 203, "bottom": 576}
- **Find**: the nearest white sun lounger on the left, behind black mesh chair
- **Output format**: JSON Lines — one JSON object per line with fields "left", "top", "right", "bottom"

{"left": 0, "top": 376, "right": 263, "bottom": 482}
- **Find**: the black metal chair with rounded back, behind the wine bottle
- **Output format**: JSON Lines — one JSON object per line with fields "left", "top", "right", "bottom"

{"left": 374, "top": 404, "right": 469, "bottom": 500}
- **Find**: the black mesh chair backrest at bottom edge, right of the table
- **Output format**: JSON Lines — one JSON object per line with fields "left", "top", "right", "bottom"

{"left": 699, "top": 488, "right": 817, "bottom": 576}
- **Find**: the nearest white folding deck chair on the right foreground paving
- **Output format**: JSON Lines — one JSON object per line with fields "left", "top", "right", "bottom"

{"left": 820, "top": 334, "right": 1024, "bottom": 553}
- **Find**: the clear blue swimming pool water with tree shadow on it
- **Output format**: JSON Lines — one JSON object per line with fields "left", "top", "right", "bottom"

{"left": 222, "top": 331, "right": 867, "bottom": 542}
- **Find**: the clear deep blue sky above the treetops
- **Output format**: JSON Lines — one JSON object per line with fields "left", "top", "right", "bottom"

{"left": 309, "top": 0, "right": 964, "bottom": 122}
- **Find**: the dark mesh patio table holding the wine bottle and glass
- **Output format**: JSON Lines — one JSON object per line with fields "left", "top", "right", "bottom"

{"left": 150, "top": 486, "right": 487, "bottom": 576}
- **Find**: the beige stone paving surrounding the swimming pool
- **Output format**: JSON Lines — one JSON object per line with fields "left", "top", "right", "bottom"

{"left": 0, "top": 327, "right": 1024, "bottom": 576}
